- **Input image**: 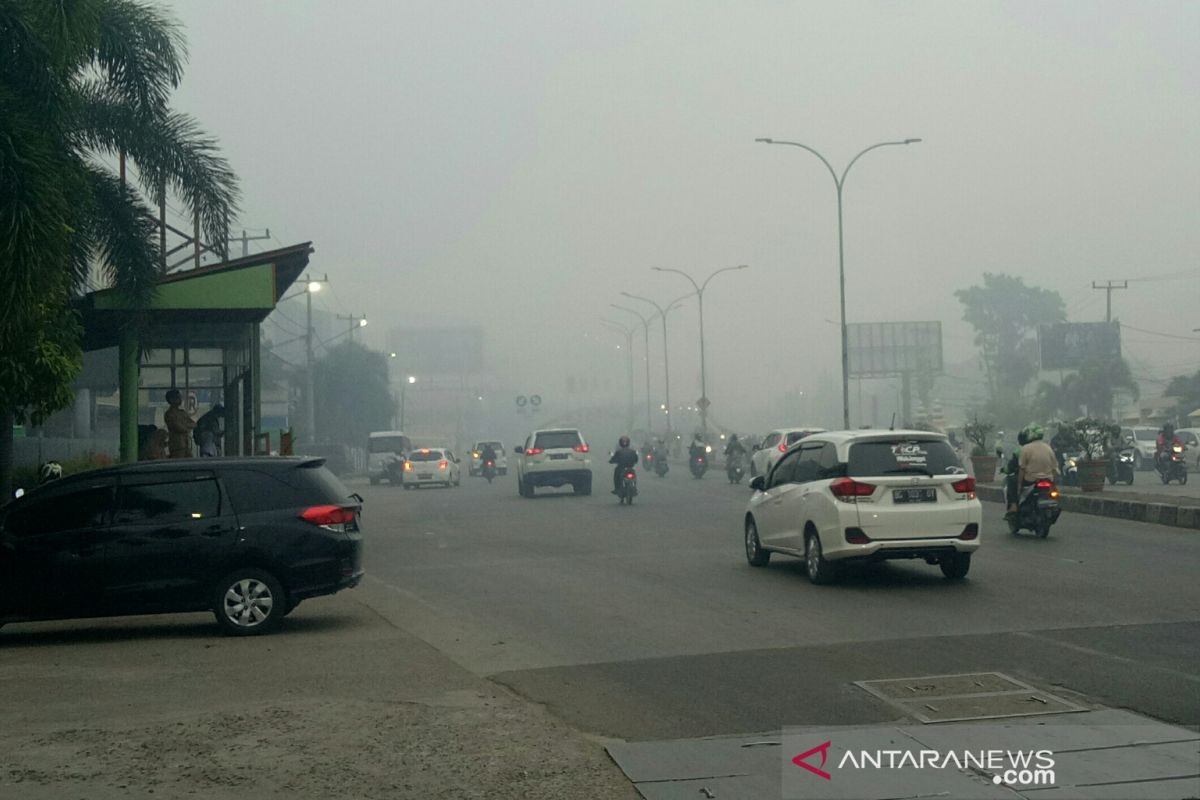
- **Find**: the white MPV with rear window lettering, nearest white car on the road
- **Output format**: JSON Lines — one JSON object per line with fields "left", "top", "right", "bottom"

{"left": 745, "top": 431, "right": 983, "bottom": 583}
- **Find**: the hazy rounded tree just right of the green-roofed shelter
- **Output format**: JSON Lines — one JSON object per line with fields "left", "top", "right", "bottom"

{"left": 313, "top": 342, "right": 395, "bottom": 446}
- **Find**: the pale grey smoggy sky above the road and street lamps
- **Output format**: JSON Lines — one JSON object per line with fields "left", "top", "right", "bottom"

{"left": 170, "top": 0, "right": 1200, "bottom": 431}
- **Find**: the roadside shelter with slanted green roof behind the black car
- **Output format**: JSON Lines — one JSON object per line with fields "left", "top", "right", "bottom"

{"left": 78, "top": 242, "right": 313, "bottom": 462}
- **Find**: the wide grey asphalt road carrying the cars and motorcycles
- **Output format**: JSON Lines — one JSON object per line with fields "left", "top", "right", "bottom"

{"left": 356, "top": 470, "right": 1200, "bottom": 740}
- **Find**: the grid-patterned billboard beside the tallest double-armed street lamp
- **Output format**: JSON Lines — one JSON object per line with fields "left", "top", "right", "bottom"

{"left": 846, "top": 321, "right": 942, "bottom": 378}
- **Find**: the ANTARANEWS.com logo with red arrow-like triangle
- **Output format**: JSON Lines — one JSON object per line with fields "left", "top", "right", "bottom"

{"left": 792, "top": 740, "right": 1056, "bottom": 787}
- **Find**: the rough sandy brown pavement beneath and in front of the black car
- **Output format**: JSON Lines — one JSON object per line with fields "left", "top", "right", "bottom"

{"left": 0, "top": 582, "right": 640, "bottom": 800}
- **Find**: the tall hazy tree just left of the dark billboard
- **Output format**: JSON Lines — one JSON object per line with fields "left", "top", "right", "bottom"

{"left": 954, "top": 272, "right": 1067, "bottom": 422}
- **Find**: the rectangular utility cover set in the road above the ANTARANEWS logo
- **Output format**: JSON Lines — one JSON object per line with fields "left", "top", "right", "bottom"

{"left": 854, "top": 672, "right": 1087, "bottom": 722}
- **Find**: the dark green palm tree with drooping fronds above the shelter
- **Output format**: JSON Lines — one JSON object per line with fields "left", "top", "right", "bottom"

{"left": 0, "top": 0, "right": 238, "bottom": 495}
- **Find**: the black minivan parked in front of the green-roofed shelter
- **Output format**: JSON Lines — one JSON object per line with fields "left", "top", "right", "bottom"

{"left": 0, "top": 457, "right": 362, "bottom": 636}
